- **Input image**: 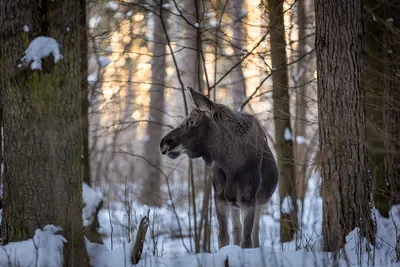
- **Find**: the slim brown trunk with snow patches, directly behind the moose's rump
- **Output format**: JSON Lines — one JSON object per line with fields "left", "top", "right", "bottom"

{"left": 268, "top": 0, "right": 297, "bottom": 242}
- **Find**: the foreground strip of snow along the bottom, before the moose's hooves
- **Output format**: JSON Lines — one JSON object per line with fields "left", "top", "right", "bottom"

{"left": 87, "top": 229, "right": 400, "bottom": 267}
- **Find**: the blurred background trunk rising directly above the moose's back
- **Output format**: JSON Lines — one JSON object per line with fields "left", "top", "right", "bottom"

{"left": 229, "top": 0, "right": 246, "bottom": 108}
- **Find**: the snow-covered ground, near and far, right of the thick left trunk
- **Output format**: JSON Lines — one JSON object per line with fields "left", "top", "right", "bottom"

{"left": 87, "top": 175, "right": 400, "bottom": 266}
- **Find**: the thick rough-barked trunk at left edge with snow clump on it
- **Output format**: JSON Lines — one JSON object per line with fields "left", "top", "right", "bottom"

{"left": 0, "top": 0, "right": 89, "bottom": 266}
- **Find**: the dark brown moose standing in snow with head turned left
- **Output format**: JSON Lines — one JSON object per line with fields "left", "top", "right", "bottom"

{"left": 160, "top": 87, "right": 279, "bottom": 248}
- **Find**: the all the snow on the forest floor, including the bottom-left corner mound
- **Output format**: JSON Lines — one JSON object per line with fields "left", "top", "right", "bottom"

{"left": 0, "top": 173, "right": 400, "bottom": 267}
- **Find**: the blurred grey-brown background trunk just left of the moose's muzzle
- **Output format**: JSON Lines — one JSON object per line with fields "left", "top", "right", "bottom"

{"left": 141, "top": 0, "right": 167, "bottom": 206}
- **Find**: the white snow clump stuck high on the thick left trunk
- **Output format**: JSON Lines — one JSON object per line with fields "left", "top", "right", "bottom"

{"left": 21, "top": 36, "right": 63, "bottom": 70}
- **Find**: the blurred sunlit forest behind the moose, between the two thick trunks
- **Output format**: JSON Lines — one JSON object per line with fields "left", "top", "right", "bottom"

{"left": 87, "top": 0, "right": 318, "bottom": 251}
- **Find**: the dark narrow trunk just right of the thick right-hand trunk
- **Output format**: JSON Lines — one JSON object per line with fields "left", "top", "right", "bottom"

{"left": 365, "top": 0, "right": 391, "bottom": 217}
